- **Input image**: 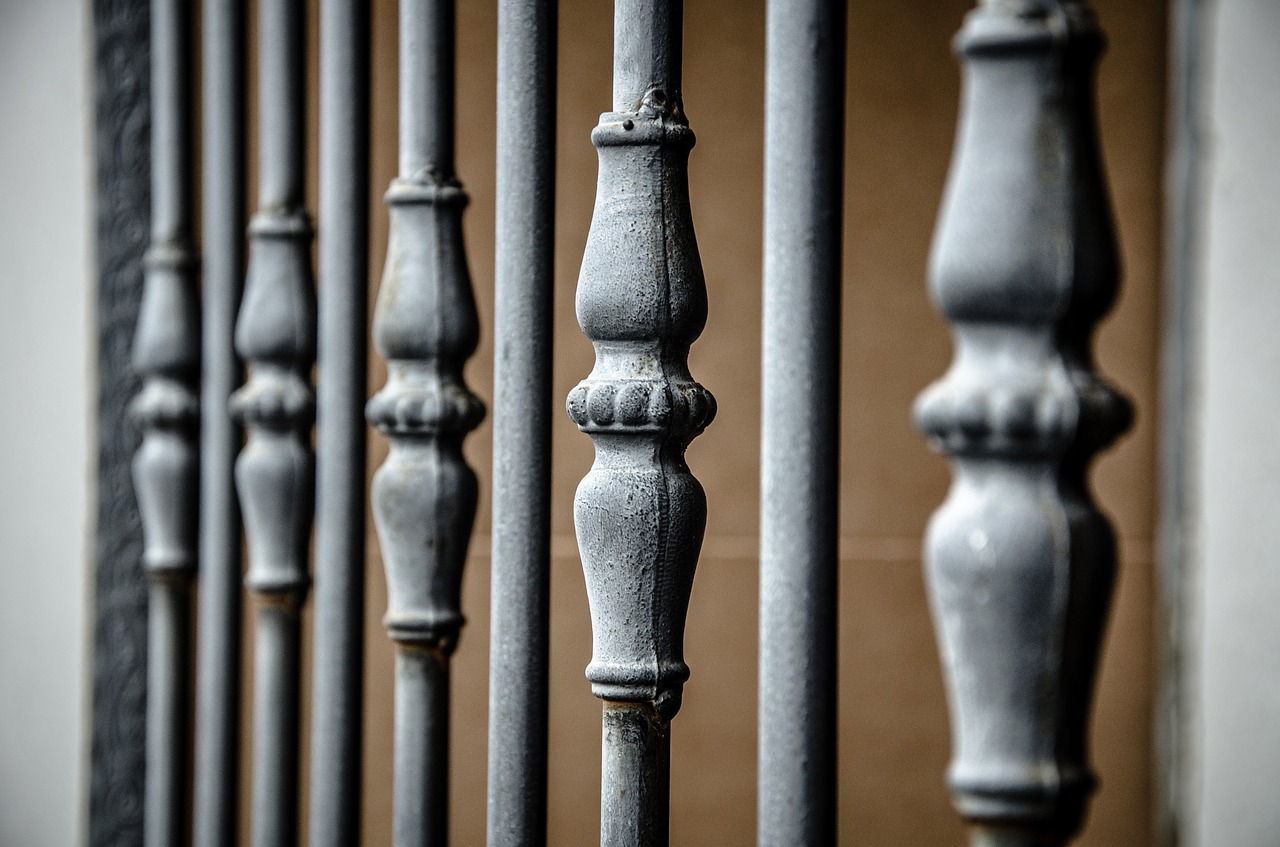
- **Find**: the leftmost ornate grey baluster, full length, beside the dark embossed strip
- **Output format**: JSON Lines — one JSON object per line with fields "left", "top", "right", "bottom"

{"left": 131, "top": 0, "right": 200, "bottom": 847}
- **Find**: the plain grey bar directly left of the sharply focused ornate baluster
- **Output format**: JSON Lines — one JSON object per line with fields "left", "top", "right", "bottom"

{"left": 488, "top": 0, "right": 557, "bottom": 847}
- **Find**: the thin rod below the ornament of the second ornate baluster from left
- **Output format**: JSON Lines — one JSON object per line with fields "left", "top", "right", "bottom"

{"left": 250, "top": 599, "right": 301, "bottom": 847}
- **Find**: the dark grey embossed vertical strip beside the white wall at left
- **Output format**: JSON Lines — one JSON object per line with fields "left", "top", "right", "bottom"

{"left": 90, "top": 0, "right": 151, "bottom": 847}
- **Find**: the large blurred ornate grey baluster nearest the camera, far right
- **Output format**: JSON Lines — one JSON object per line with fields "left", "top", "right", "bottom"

{"left": 916, "top": 0, "right": 1132, "bottom": 847}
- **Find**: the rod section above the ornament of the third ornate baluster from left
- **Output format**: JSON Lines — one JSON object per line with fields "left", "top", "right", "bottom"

{"left": 399, "top": 0, "right": 456, "bottom": 177}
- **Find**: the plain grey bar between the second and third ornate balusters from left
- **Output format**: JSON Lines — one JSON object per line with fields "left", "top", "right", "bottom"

{"left": 310, "top": 0, "right": 370, "bottom": 847}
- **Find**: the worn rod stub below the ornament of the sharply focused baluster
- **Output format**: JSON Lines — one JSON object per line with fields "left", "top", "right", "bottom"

{"left": 600, "top": 702, "right": 671, "bottom": 847}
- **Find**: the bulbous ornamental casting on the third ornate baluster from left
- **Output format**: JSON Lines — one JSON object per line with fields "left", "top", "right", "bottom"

{"left": 366, "top": 171, "right": 484, "bottom": 653}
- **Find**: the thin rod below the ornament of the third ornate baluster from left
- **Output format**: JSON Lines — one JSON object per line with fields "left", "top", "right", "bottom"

{"left": 392, "top": 645, "right": 449, "bottom": 847}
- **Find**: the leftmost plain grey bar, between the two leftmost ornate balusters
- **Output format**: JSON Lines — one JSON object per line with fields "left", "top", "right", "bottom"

{"left": 193, "top": 0, "right": 246, "bottom": 847}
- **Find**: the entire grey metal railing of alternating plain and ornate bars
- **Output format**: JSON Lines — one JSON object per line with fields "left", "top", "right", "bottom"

{"left": 115, "top": 0, "right": 1130, "bottom": 847}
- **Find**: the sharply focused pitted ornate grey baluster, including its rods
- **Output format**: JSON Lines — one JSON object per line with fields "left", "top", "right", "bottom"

{"left": 568, "top": 0, "right": 716, "bottom": 847}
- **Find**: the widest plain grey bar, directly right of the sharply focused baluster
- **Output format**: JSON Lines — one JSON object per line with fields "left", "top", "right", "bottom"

{"left": 758, "top": 0, "right": 846, "bottom": 847}
